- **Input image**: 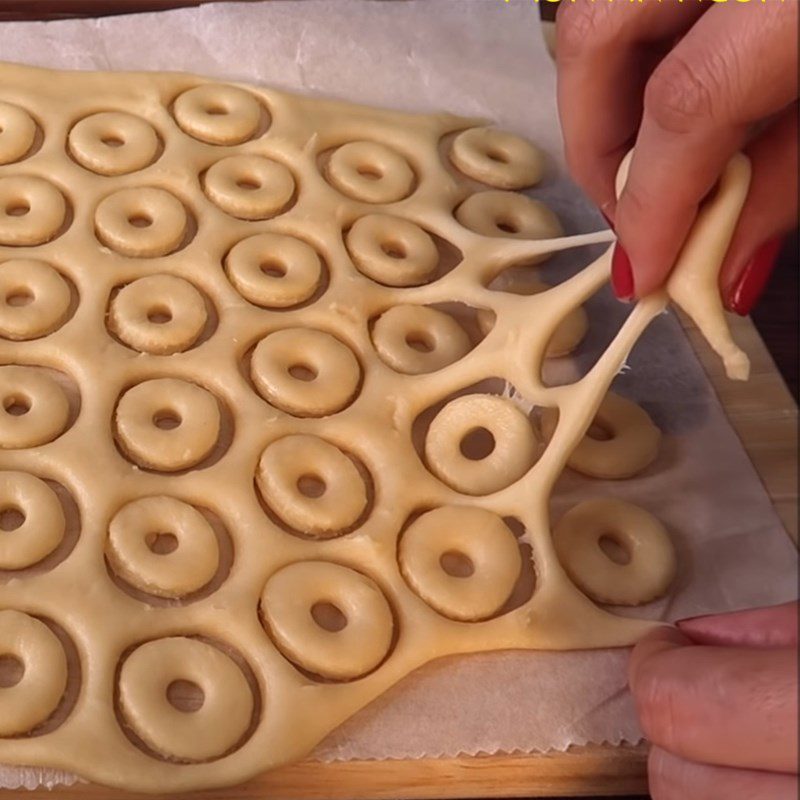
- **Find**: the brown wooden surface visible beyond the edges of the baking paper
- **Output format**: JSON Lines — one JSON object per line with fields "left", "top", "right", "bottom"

{"left": 0, "top": 0, "right": 798, "bottom": 800}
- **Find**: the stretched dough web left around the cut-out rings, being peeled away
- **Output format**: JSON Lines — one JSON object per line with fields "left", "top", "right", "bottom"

{"left": 0, "top": 64, "right": 752, "bottom": 792}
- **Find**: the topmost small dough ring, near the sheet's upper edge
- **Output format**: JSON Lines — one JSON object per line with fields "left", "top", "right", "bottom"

{"left": 173, "top": 83, "right": 262, "bottom": 145}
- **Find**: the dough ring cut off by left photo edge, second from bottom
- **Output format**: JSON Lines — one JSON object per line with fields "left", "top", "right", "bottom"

{"left": 0, "top": 472, "right": 67, "bottom": 569}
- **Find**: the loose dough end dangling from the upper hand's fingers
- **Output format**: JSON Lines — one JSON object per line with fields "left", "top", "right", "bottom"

{"left": 617, "top": 150, "right": 751, "bottom": 381}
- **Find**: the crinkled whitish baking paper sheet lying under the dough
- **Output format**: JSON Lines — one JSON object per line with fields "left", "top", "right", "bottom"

{"left": 0, "top": 0, "right": 797, "bottom": 786}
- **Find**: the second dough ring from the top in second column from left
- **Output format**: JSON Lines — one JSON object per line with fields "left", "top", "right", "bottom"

{"left": 94, "top": 188, "right": 188, "bottom": 258}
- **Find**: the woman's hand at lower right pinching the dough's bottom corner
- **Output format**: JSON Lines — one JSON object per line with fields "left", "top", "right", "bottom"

{"left": 630, "top": 603, "right": 798, "bottom": 800}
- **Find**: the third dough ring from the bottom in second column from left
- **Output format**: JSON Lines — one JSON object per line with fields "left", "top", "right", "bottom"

{"left": 115, "top": 378, "right": 220, "bottom": 472}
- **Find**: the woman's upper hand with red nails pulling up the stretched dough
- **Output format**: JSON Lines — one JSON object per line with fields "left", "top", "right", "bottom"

{"left": 556, "top": 0, "right": 800, "bottom": 314}
